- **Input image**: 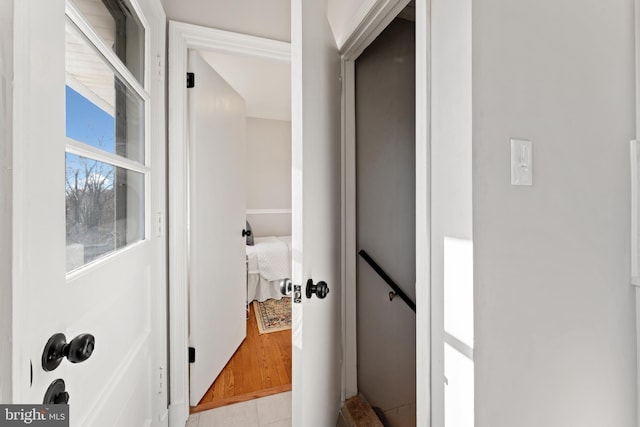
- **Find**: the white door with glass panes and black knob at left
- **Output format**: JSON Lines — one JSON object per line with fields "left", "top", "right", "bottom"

{"left": 12, "top": 0, "right": 166, "bottom": 426}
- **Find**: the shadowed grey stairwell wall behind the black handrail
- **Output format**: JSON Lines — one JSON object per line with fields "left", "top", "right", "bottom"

{"left": 355, "top": 19, "right": 416, "bottom": 426}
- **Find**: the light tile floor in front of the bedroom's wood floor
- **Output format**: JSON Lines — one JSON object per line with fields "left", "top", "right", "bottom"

{"left": 186, "top": 391, "right": 291, "bottom": 427}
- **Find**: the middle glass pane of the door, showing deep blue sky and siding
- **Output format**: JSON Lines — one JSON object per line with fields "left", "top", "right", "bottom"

{"left": 66, "top": 22, "right": 144, "bottom": 163}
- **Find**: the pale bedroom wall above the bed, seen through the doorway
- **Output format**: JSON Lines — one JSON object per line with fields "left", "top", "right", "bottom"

{"left": 245, "top": 117, "right": 291, "bottom": 237}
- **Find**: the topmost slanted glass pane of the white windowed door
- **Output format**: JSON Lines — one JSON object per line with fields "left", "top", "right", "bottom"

{"left": 73, "top": 0, "right": 144, "bottom": 85}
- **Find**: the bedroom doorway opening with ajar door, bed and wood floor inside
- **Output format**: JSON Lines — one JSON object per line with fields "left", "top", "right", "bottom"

{"left": 187, "top": 49, "right": 291, "bottom": 413}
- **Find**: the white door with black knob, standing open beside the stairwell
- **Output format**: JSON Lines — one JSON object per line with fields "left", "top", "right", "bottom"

{"left": 291, "top": 0, "right": 342, "bottom": 427}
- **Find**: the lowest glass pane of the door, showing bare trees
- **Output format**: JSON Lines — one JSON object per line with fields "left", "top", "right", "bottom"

{"left": 65, "top": 153, "right": 144, "bottom": 271}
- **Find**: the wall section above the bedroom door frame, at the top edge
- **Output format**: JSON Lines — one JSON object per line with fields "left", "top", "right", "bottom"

{"left": 163, "top": 0, "right": 291, "bottom": 42}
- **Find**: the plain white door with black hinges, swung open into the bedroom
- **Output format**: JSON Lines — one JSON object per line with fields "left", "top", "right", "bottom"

{"left": 188, "top": 50, "right": 247, "bottom": 406}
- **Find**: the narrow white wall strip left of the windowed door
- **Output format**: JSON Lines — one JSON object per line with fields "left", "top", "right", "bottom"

{"left": 0, "top": 0, "right": 13, "bottom": 403}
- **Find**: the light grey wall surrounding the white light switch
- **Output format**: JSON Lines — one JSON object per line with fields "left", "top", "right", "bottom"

{"left": 473, "top": 0, "right": 636, "bottom": 427}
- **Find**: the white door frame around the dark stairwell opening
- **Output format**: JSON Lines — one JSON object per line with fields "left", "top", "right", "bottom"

{"left": 342, "top": 0, "right": 432, "bottom": 426}
